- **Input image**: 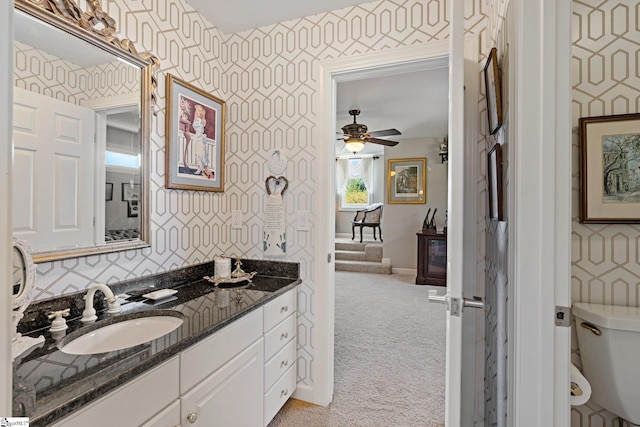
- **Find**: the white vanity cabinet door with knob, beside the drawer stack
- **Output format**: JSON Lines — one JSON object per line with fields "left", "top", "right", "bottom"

{"left": 181, "top": 338, "right": 264, "bottom": 427}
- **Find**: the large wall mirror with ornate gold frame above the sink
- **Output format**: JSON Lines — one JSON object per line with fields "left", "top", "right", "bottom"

{"left": 13, "top": 0, "right": 158, "bottom": 262}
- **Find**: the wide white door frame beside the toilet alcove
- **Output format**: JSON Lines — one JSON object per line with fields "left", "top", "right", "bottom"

{"left": 507, "top": 0, "right": 572, "bottom": 426}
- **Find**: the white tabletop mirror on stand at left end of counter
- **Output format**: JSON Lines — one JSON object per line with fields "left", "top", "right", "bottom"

{"left": 11, "top": 237, "right": 44, "bottom": 360}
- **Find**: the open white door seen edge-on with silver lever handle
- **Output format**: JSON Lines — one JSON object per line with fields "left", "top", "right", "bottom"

{"left": 429, "top": 1, "right": 484, "bottom": 426}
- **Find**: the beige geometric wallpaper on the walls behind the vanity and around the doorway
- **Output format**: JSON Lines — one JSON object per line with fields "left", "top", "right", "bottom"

{"left": 18, "top": 0, "right": 484, "bottom": 400}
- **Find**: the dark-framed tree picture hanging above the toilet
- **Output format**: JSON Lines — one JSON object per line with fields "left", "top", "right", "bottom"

{"left": 579, "top": 114, "right": 640, "bottom": 224}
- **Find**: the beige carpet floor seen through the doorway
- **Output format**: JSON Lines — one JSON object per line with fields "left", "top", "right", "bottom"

{"left": 269, "top": 272, "right": 445, "bottom": 427}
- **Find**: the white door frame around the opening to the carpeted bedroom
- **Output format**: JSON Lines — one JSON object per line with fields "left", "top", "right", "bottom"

{"left": 316, "top": 40, "right": 464, "bottom": 406}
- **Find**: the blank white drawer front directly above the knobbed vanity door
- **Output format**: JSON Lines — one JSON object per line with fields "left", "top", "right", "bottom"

{"left": 180, "top": 307, "right": 262, "bottom": 393}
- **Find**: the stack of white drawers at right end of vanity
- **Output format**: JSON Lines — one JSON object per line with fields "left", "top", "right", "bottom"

{"left": 264, "top": 289, "right": 297, "bottom": 426}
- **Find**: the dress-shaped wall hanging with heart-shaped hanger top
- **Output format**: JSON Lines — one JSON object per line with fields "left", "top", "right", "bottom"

{"left": 262, "top": 175, "right": 289, "bottom": 257}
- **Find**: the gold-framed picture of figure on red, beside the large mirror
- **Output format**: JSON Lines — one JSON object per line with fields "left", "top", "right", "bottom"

{"left": 165, "top": 74, "right": 226, "bottom": 191}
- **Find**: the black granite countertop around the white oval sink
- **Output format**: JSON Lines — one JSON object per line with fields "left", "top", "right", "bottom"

{"left": 14, "top": 260, "right": 301, "bottom": 427}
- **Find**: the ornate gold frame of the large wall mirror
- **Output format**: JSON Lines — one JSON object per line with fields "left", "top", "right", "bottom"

{"left": 15, "top": 0, "right": 160, "bottom": 262}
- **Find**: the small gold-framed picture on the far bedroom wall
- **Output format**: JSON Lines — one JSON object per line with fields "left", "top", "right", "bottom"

{"left": 387, "top": 157, "right": 427, "bottom": 204}
